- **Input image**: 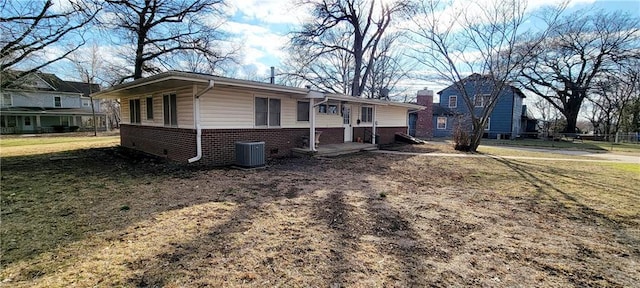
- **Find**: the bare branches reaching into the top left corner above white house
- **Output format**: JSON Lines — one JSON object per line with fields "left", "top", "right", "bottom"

{"left": 0, "top": 0, "right": 100, "bottom": 87}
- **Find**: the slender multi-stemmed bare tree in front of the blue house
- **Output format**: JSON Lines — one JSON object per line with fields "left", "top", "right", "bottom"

{"left": 409, "top": 0, "right": 561, "bottom": 151}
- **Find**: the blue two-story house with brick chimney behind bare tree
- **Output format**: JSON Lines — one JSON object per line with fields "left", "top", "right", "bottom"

{"left": 433, "top": 74, "right": 526, "bottom": 139}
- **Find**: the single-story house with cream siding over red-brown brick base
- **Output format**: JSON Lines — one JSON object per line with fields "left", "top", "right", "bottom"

{"left": 93, "top": 71, "right": 423, "bottom": 165}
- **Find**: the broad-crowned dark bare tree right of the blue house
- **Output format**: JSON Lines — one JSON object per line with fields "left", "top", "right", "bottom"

{"left": 521, "top": 10, "right": 640, "bottom": 133}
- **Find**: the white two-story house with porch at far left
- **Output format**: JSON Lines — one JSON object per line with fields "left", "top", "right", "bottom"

{"left": 0, "top": 70, "right": 106, "bottom": 134}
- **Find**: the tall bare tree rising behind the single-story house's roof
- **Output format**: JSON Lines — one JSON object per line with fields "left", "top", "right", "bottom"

{"left": 291, "top": 0, "right": 406, "bottom": 96}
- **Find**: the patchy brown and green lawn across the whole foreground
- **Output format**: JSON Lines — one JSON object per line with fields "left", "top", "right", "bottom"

{"left": 0, "top": 141, "right": 640, "bottom": 287}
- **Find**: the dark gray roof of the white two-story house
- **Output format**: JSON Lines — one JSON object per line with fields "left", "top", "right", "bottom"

{"left": 1, "top": 70, "right": 100, "bottom": 97}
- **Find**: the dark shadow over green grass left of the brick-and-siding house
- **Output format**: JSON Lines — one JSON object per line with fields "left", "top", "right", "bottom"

{"left": 0, "top": 147, "right": 218, "bottom": 266}
